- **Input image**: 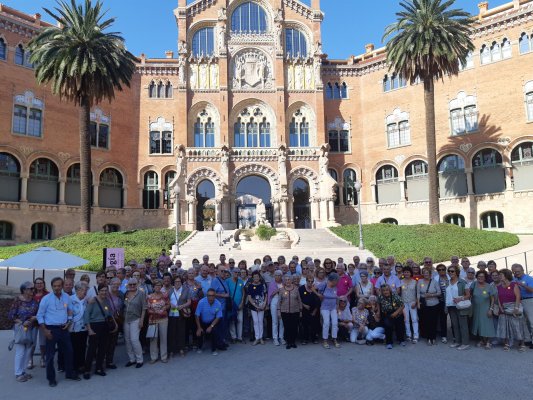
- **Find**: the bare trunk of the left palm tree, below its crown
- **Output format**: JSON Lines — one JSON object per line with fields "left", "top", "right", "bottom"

{"left": 80, "top": 98, "right": 92, "bottom": 233}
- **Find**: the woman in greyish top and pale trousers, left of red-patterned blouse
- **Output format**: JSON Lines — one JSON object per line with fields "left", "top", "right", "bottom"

{"left": 124, "top": 278, "right": 146, "bottom": 368}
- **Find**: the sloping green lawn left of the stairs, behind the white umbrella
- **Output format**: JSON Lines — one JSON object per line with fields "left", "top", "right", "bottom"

{"left": 0, "top": 229, "right": 190, "bottom": 271}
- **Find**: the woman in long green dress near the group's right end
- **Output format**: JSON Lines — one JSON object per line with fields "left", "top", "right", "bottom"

{"left": 467, "top": 271, "right": 498, "bottom": 350}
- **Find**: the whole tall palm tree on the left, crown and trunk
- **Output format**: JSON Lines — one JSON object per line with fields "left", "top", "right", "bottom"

{"left": 29, "top": 0, "right": 136, "bottom": 232}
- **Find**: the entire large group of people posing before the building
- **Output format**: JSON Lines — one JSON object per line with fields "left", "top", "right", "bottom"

{"left": 9, "top": 251, "right": 533, "bottom": 387}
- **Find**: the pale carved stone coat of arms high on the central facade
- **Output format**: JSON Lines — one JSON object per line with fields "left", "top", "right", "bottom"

{"left": 233, "top": 49, "right": 273, "bottom": 89}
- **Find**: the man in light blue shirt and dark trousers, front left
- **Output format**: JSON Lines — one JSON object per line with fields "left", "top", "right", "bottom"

{"left": 37, "top": 274, "right": 80, "bottom": 387}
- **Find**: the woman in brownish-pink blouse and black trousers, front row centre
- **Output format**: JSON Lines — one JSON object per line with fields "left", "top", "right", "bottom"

{"left": 277, "top": 275, "right": 302, "bottom": 350}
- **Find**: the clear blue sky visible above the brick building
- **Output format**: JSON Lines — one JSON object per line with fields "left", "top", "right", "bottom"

{"left": 9, "top": 0, "right": 511, "bottom": 59}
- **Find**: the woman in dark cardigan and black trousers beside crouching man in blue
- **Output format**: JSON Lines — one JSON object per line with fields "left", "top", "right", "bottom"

{"left": 168, "top": 276, "right": 191, "bottom": 357}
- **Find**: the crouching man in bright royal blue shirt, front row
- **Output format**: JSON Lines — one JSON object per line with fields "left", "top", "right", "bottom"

{"left": 195, "top": 289, "right": 222, "bottom": 356}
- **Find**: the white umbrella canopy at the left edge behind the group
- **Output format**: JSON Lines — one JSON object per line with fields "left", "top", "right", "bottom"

{"left": 0, "top": 247, "right": 89, "bottom": 270}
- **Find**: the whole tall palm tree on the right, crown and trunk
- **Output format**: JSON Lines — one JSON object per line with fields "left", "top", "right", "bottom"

{"left": 383, "top": 0, "right": 474, "bottom": 224}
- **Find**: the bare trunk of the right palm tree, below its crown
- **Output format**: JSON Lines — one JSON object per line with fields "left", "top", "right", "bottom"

{"left": 424, "top": 78, "right": 440, "bottom": 225}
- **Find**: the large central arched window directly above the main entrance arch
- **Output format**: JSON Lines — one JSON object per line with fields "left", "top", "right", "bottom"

{"left": 233, "top": 107, "right": 271, "bottom": 147}
